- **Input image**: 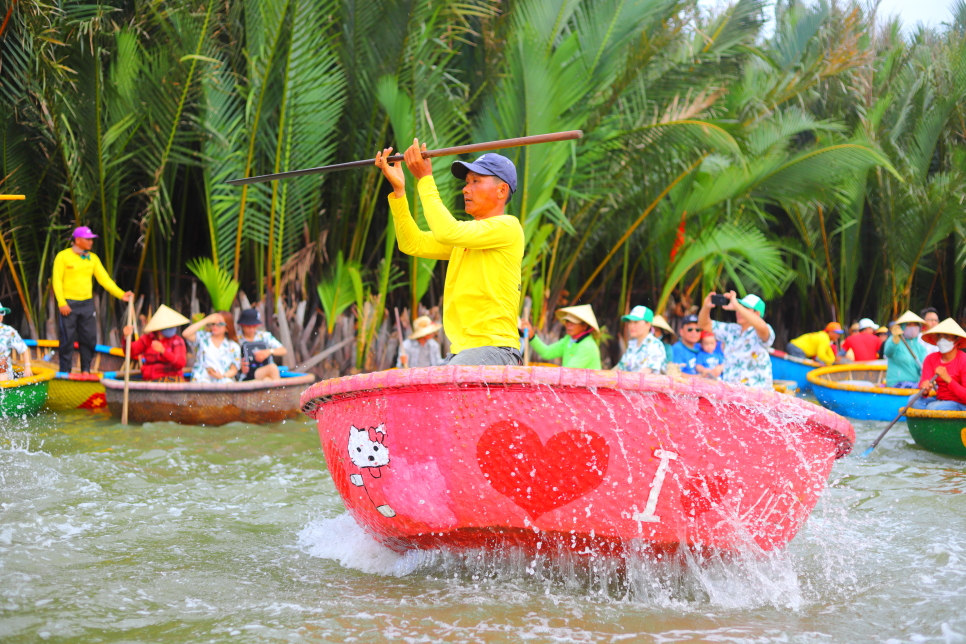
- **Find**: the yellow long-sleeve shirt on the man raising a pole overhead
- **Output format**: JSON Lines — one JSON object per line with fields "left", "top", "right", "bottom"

{"left": 389, "top": 176, "right": 523, "bottom": 353}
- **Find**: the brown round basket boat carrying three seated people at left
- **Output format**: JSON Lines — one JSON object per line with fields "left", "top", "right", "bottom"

{"left": 101, "top": 371, "right": 315, "bottom": 427}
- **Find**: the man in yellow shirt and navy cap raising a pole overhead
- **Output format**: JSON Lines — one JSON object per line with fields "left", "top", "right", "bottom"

{"left": 376, "top": 139, "right": 523, "bottom": 365}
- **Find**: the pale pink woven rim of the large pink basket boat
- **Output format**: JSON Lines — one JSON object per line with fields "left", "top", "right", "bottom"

{"left": 300, "top": 366, "right": 855, "bottom": 455}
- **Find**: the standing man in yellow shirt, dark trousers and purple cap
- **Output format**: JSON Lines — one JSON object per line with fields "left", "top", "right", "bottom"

{"left": 51, "top": 226, "right": 134, "bottom": 373}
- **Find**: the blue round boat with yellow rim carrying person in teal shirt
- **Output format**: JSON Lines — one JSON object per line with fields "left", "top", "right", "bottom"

{"left": 808, "top": 362, "right": 917, "bottom": 421}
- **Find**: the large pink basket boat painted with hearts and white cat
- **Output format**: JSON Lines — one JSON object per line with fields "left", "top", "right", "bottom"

{"left": 302, "top": 366, "right": 855, "bottom": 554}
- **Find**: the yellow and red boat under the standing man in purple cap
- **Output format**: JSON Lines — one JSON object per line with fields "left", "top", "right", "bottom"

{"left": 24, "top": 340, "right": 130, "bottom": 411}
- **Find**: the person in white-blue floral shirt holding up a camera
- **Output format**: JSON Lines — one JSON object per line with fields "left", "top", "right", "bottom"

{"left": 698, "top": 291, "right": 775, "bottom": 390}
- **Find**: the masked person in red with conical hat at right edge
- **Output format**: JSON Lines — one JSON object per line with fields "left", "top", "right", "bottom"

{"left": 910, "top": 318, "right": 966, "bottom": 411}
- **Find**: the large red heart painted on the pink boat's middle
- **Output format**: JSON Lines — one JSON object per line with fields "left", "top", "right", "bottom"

{"left": 476, "top": 421, "right": 610, "bottom": 519}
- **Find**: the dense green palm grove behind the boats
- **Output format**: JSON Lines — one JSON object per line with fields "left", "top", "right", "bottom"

{"left": 0, "top": 0, "right": 966, "bottom": 370}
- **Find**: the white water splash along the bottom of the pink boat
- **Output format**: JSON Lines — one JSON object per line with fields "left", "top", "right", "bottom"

{"left": 298, "top": 513, "right": 807, "bottom": 612}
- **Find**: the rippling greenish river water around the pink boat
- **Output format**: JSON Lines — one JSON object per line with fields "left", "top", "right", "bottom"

{"left": 0, "top": 412, "right": 966, "bottom": 644}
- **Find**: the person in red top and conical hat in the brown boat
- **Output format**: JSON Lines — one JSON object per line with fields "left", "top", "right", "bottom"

{"left": 124, "top": 304, "right": 188, "bottom": 382}
